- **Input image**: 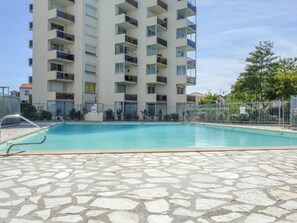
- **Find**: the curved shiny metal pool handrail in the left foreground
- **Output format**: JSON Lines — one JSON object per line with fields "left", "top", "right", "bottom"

{"left": 0, "top": 114, "right": 47, "bottom": 156}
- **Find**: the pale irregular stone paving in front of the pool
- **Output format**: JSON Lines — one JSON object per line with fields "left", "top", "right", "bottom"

{"left": 0, "top": 150, "right": 297, "bottom": 223}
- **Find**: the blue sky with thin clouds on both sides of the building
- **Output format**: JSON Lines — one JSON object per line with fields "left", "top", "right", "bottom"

{"left": 0, "top": 0, "right": 297, "bottom": 93}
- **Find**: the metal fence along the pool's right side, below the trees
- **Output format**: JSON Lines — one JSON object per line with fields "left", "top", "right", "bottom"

{"left": 195, "top": 101, "right": 290, "bottom": 126}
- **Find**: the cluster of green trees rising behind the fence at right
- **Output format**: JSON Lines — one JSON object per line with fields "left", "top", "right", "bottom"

{"left": 227, "top": 41, "right": 297, "bottom": 101}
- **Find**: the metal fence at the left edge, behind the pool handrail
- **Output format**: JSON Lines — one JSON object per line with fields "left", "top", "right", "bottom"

{"left": 0, "top": 95, "right": 20, "bottom": 125}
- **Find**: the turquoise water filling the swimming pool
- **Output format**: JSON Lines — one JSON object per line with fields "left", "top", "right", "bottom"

{"left": 0, "top": 123, "right": 297, "bottom": 151}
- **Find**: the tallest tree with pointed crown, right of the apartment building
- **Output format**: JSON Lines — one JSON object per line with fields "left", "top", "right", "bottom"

{"left": 231, "top": 41, "right": 278, "bottom": 101}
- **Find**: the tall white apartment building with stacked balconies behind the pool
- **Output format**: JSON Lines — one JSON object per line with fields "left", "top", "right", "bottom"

{"left": 29, "top": 0, "right": 197, "bottom": 115}
